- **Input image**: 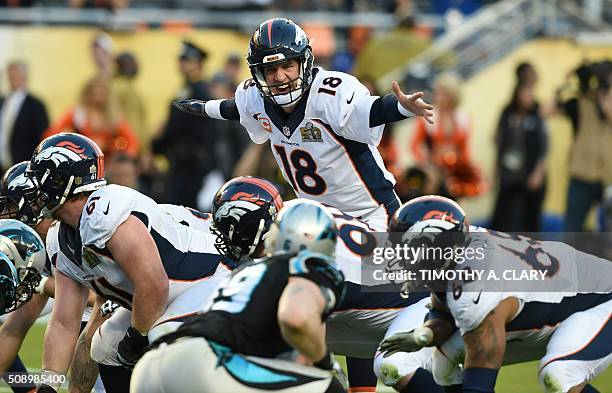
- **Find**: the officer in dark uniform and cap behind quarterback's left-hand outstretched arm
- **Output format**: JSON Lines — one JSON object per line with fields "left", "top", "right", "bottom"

{"left": 152, "top": 41, "right": 221, "bottom": 208}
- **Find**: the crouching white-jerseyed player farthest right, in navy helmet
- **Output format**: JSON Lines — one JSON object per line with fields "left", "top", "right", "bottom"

{"left": 381, "top": 196, "right": 612, "bottom": 393}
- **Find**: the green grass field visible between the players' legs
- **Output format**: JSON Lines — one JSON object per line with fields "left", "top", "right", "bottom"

{"left": 0, "top": 324, "right": 612, "bottom": 393}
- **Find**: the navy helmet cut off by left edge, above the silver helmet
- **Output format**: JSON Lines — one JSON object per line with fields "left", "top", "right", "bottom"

{"left": 0, "top": 161, "right": 42, "bottom": 227}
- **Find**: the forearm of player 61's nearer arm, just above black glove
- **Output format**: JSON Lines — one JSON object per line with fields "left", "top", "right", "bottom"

{"left": 132, "top": 282, "right": 168, "bottom": 333}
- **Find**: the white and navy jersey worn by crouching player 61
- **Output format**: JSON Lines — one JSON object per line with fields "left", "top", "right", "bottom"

{"left": 47, "top": 185, "right": 236, "bottom": 308}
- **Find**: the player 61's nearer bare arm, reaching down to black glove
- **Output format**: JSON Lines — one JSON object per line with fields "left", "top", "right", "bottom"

{"left": 106, "top": 216, "right": 168, "bottom": 335}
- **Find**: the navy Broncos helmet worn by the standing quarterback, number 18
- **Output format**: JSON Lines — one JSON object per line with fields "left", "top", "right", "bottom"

{"left": 247, "top": 18, "right": 314, "bottom": 107}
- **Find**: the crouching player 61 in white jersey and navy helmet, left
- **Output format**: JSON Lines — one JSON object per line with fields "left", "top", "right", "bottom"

{"left": 23, "top": 134, "right": 235, "bottom": 388}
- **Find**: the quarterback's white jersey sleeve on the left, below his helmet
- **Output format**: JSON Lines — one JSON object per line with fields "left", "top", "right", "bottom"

{"left": 234, "top": 79, "right": 272, "bottom": 144}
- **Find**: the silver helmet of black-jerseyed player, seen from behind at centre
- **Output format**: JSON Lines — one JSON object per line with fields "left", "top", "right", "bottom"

{"left": 266, "top": 199, "right": 338, "bottom": 258}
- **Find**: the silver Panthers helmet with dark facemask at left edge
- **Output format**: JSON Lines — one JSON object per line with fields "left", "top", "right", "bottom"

{"left": 0, "top": 220, "right": 47, "bottom": 307}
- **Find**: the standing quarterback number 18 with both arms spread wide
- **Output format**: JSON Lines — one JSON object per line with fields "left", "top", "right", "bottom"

{"left": 175, "top": 18, "right": 433, "bottom": 231}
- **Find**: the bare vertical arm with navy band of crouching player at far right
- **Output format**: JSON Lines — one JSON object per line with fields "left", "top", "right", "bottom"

{"left": 463, "top": 298, "right": 518, "bottom": 393}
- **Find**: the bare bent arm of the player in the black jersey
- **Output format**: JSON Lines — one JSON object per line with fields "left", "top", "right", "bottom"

{"left": 278, "top": 277, "right": 327, "bottom": 363}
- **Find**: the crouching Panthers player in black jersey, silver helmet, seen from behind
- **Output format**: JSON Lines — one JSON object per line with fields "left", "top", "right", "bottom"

{"left": 131, "top": 201, "right": 345, "bottom": 393}
